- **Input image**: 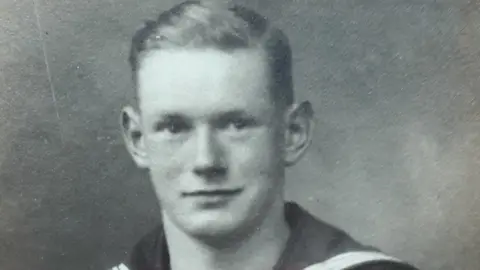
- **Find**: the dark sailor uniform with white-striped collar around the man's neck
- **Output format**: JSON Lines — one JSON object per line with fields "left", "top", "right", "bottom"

{"left": 112, "top": 202, "right": 418, "bottom": 270}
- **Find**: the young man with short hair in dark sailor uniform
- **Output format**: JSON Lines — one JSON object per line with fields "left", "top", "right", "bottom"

{"left": 113, "top": 1, "right": 414, "bottom": 270}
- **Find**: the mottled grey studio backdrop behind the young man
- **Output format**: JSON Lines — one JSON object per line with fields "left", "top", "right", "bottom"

{"left": 0, "top": 0, "right": 480, "bottom": 270}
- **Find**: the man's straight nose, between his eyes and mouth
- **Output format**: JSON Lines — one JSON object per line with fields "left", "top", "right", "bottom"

{"left": 193, "top": 127, "right": 226, "bottom": 179}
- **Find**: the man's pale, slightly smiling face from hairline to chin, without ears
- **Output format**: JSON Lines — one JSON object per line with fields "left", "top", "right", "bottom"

{"left": 138, "top": 49, "right": 284, "bottom": 236}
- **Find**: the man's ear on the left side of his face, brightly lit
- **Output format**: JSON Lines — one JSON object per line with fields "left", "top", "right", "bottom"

{"left": 120, "top": 106, "right": 149, "bottom": 168}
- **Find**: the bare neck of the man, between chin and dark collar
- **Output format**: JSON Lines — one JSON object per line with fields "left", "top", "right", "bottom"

{"left": 163, "top": 200, "right": 290, "bottom": 270}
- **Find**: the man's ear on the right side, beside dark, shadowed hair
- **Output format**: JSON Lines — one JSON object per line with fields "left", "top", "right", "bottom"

{"left": 284, "top": 101, "right": 314, "bottom": 166}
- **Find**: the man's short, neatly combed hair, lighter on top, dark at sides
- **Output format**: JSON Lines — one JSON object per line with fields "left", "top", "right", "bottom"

{"left": 129, "top": 1, "right": 294, "bottom": 105}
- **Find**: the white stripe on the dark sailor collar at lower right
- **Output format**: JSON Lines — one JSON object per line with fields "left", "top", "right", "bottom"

{"left": 304, "top": 251, "right": 401, "bottom": 270}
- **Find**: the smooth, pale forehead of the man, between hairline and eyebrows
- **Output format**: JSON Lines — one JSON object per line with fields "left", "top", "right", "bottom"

{"left": 138, "top": 49, "right": 271, "bottom": 117}
